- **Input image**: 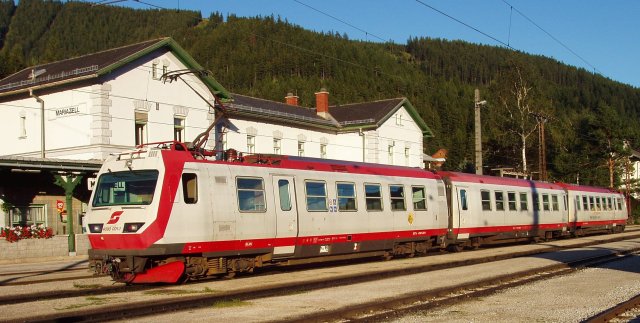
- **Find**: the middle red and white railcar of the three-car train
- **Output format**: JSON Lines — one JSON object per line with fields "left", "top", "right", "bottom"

{"left": 439, "top": 172, "right": 568, "bottom": 247}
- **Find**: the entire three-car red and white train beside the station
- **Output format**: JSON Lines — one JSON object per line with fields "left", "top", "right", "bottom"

{"left": 84, "top": 141, "right": 628, "bottom": 284}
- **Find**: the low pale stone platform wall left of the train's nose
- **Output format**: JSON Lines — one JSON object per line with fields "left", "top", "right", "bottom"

{"left": 0, "top": 234, "right": 89, "bottom": 262}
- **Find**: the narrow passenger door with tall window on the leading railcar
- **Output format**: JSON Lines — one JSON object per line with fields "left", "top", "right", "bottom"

{"left": 272, "top": 175, "right": 298, "bottom": 257}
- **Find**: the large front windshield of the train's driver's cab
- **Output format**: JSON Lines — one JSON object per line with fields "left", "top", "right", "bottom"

{"left": 92, "top": 170, "right": 158, "bottom": 206}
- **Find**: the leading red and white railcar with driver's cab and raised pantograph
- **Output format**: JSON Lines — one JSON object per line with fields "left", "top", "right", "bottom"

{"left": 85, "top": 142, "right": 448, "bottom": 283}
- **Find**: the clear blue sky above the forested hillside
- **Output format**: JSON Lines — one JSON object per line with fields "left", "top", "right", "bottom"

{"left": 107, "top": 0, "right": 640, "bottom": 88}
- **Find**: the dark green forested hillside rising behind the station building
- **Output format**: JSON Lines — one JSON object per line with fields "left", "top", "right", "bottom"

{"left": 0, "top": 0, "right": 640, "bottom": 189}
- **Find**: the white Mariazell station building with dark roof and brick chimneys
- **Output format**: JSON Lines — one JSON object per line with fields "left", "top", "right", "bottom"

{"left": 0, "top": 38, "right": 432, "bottom": 234}
